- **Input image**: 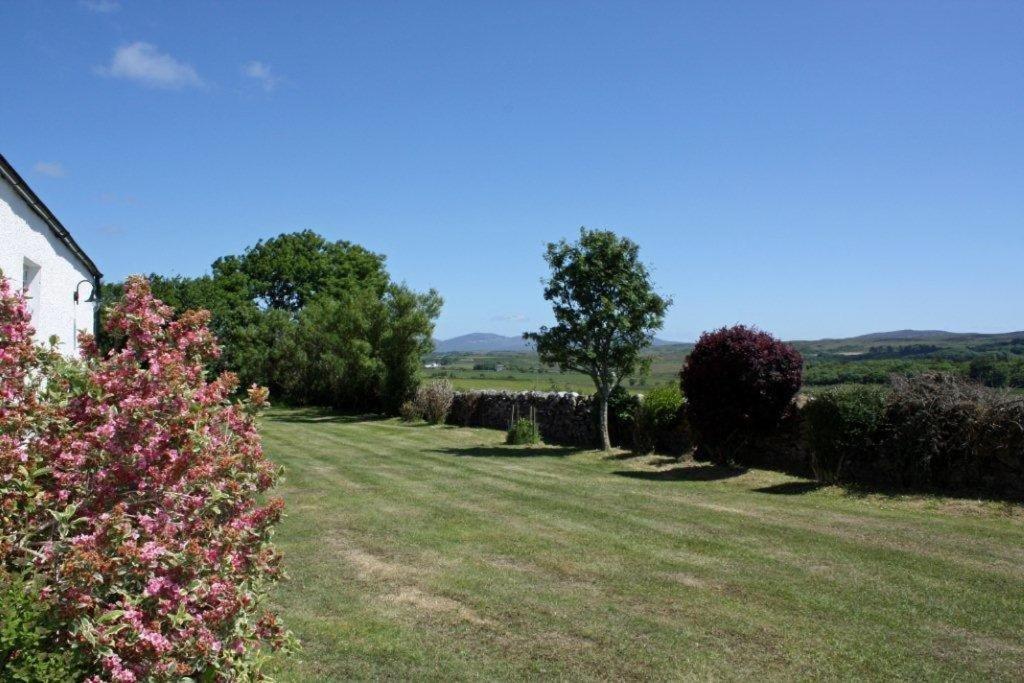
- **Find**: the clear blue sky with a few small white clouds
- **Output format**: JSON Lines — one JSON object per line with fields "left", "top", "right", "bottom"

{"left": 0, "top": 0, "right": 1024, "bottom": 340}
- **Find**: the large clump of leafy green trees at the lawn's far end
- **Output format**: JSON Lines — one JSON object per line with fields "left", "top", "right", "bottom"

{"left": 98, "top": 230, "right": 442, "bottom": 414}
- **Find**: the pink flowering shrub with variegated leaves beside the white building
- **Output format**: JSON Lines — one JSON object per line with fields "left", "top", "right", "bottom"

{"left": 0, "top": 278, "right": 287, "bottom": 681}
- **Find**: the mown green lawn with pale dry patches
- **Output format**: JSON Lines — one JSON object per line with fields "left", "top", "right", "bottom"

{"left": 263, "top": 410, "right": 1024, "bottom": 681}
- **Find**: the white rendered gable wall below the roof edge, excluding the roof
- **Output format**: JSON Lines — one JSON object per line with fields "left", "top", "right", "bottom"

{"left": 0, "top": 178, "right": 94, "bottom": 355}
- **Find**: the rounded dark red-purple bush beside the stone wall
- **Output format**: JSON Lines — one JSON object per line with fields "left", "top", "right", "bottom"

{"left": 681, "top": 325, "right": 804, "bottom": 462}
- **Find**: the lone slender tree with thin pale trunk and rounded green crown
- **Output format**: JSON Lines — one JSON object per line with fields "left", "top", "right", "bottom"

{"left": 523, "top": 227, "right": 672, "bottom": 451}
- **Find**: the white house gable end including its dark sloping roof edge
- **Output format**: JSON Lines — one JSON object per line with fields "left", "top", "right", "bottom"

{"left": 0, "top": 155, "right": 102, "bottom": 355}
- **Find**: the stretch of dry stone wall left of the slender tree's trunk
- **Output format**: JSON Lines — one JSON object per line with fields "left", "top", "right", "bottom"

{"left": 447, "top": 390, "right": 598, "bottom": 447}
